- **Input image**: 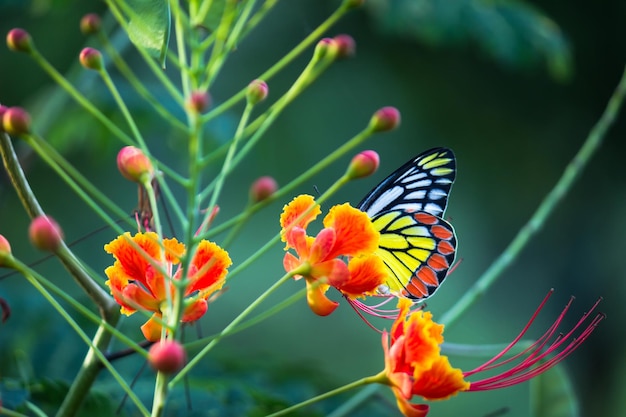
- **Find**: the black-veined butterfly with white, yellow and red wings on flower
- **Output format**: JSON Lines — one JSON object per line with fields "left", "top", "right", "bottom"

{"left": 358, "top": 148, "right": 456, "bottom": 302}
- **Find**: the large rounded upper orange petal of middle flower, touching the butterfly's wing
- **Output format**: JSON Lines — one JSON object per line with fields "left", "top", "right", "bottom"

{"left": 324, "top": 203, "right": 380, "bottom": 258}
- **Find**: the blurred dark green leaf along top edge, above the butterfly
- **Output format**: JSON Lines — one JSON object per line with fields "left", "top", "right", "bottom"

{"left": 365, "top": 0, "right": 573, "bottom": 81}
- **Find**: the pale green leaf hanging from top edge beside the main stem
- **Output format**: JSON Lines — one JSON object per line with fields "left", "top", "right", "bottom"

{"left": 128, "top": 0, "right": 170, "bottom": 66}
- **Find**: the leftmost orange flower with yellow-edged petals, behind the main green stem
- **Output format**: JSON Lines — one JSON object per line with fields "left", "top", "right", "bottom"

{"left": 104, "top": 232, "right": 232, "bottom": 341}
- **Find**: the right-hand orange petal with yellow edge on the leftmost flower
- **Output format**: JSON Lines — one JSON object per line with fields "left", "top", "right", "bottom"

{"left": 185, "top": 240, "right": 233, "bottom": 298}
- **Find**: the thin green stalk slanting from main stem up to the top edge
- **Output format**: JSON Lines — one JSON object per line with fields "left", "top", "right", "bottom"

{"left": 203, "top": 1, "right": 350, "bottom": 123}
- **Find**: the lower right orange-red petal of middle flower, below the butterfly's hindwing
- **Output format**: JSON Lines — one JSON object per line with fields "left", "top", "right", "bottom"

{"left": 337, "top": 255, "right": 387, "bottom": 298}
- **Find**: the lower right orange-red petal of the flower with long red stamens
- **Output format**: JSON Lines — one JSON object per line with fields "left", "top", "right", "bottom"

{"left": 413, "top": 356, "right": 470, "bottom": 400}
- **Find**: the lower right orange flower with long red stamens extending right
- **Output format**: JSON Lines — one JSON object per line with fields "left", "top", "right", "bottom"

{"left": 379, "top": 294, "right": 604, "bottom": 417}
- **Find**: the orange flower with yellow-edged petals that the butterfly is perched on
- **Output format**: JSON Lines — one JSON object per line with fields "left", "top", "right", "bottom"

{"left": 280, "top": 195, "right": 386, "bottom": 316}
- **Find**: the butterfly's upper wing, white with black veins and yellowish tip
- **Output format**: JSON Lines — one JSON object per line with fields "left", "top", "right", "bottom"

{"left": 358, "top": 148, "right": 456, "bottom": 218}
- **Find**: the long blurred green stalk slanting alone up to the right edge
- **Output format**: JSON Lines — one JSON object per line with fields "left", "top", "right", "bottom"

{"left": 441, "top": 68, "right": 626, "bottom": 326}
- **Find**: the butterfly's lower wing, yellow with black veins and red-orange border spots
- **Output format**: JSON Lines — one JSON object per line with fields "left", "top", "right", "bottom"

{"left": 372, "top": 209, "right": 456, "bottom": 301}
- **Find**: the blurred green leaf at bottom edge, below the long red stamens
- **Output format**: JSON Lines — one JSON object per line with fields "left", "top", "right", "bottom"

{"left": 530, "top": 365, "right": 580, "bottom": 417}
